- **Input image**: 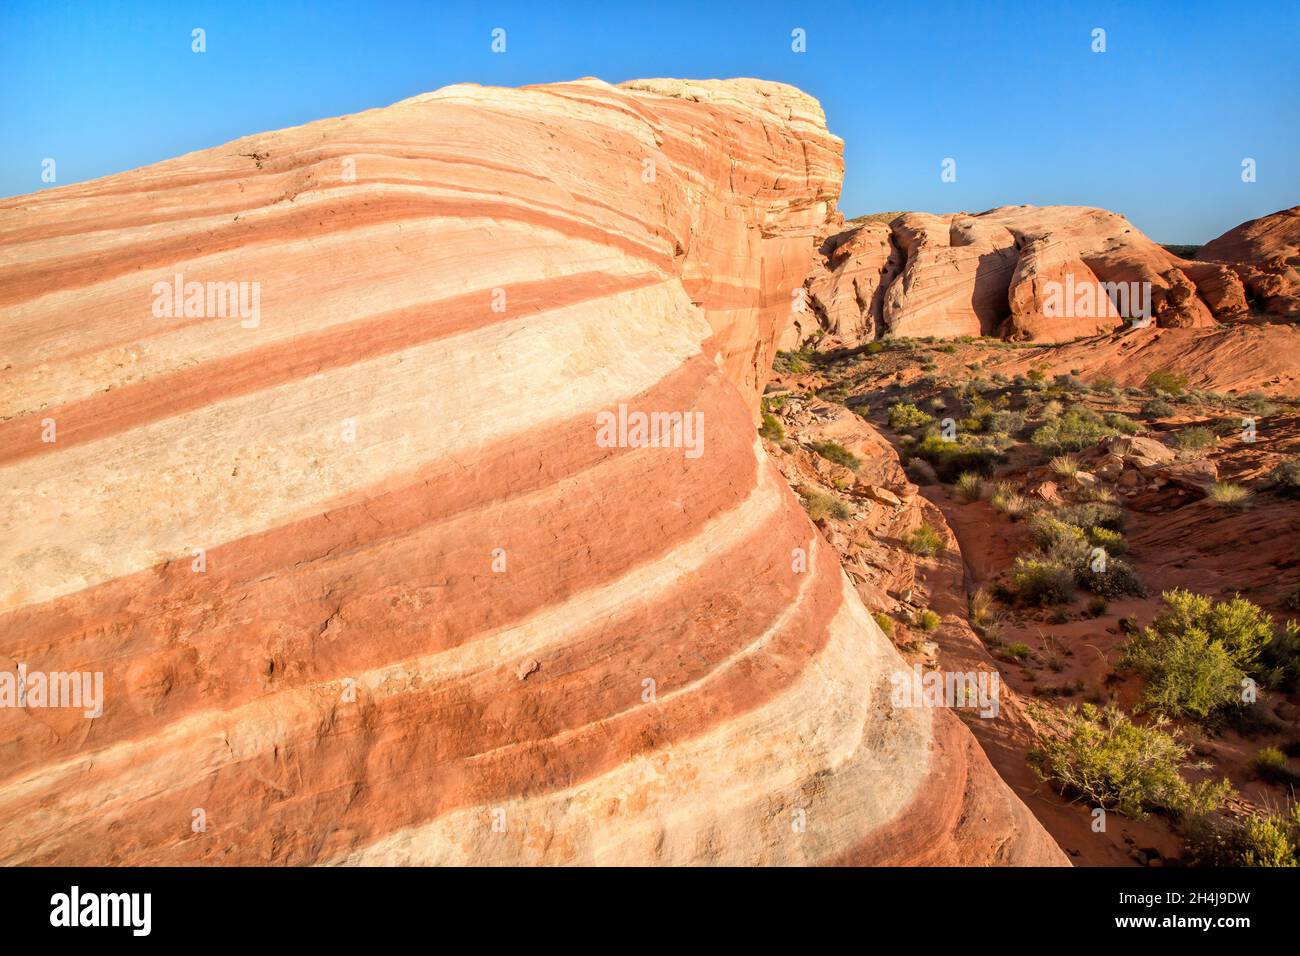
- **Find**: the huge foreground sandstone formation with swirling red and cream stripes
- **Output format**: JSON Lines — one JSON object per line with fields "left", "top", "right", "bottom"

{"left": 0, "top": 79, "right": 1063, "bottom": 865}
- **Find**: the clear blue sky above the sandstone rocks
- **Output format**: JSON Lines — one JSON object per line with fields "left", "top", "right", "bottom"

{"left": 0, "top": 0, "right": 1300, "bottom": 242}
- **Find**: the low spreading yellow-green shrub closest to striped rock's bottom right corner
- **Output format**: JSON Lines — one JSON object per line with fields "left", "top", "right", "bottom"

{"left": 1030, "top": 704, "right": 1231, "bottom": 819}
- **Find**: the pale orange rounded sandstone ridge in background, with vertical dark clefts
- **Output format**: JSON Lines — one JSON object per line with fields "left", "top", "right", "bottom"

{"left": 806, "top": 206, "right": 1257, "bottom": 343}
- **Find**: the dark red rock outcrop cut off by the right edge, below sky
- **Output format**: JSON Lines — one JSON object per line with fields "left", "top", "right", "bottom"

{"left": 1196, "top": 206, "right": 1300, "bottom": 316}
